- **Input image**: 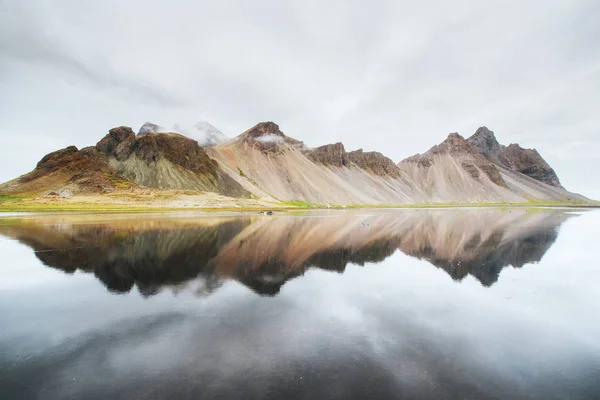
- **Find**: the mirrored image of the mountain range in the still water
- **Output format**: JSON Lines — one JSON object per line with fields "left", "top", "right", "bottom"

{"left": 0, "top": 209, "right": 570, "bottom": 296}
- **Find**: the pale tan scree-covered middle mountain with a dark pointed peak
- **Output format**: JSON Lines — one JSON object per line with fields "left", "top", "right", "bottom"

{"left": 207, "top": 122, "right": 423, "bottom": 204}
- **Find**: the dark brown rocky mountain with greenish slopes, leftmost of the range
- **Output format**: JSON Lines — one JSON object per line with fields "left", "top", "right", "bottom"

{"left": 0, "top": 126, "right": 249, "bottom": 197}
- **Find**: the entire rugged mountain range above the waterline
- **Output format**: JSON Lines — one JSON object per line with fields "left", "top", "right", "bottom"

{"left": 0, "top": 122, "right": 591, "bottom": 206}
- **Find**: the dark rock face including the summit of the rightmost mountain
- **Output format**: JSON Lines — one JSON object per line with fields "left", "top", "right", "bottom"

{"left": 468, "top": 126, "right": 562, "bottom": 188}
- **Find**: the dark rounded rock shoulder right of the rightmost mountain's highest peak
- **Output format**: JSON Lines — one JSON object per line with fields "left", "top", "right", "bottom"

{"left": 503, "top": 144, "right": 562, "bottom": 188}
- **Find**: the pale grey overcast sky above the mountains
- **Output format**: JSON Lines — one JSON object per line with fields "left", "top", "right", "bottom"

{"left": 0, "top": 0, "right": 600, "bottom": 198}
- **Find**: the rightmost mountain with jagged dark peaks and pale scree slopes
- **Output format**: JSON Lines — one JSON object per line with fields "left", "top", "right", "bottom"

{"left": 398, "top": 127, "right": 589, "bottom": 203}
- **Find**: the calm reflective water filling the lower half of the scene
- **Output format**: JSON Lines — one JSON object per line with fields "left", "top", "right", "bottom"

{"left": 0, "top": 209, "right": 600, "bottom": 400}
